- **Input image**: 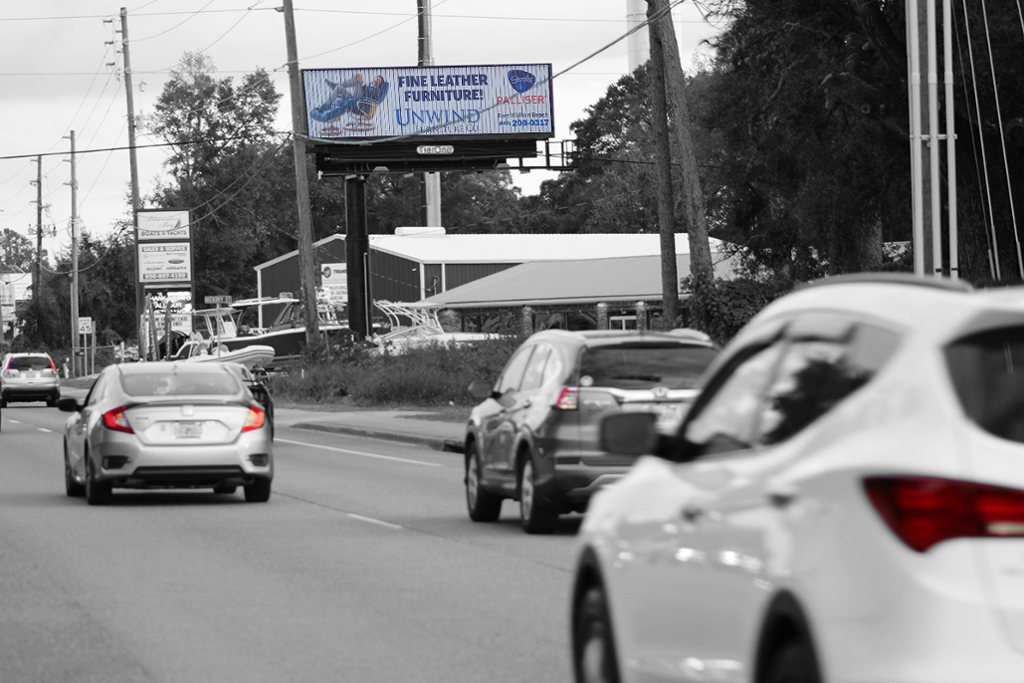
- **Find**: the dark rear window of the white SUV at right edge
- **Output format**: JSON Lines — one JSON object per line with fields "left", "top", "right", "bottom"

{"left": 945, "top": 327, "right": 1024, "bottom": 443}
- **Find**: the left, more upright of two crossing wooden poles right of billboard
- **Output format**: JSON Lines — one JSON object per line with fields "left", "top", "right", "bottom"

{"left": 647, "top": 17, "right": 679, "bottom": 328}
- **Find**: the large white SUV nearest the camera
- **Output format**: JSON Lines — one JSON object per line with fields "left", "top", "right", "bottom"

{"left": 571, "top": 275, "right": 1024, "bottom": 683}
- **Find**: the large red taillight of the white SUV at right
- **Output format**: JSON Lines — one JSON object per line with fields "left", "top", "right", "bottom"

{"left": 864, "top": 476, "right": 1024, "bottom": 553}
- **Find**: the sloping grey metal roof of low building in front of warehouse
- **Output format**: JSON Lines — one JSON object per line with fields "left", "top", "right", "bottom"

{"left": 422, "top": 254, "right": 733, "bottom": 308}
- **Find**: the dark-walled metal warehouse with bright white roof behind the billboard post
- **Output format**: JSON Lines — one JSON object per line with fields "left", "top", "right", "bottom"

{"left": 256, "top": 227, "right": 722, "bottom": 327}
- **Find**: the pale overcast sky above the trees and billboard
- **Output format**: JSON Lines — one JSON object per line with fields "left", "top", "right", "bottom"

{"left": 0, "top": 0, "right": 717, "bottom": 258}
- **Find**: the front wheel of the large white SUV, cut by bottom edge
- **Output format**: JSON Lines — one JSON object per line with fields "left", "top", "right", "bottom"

{"left": 572, "top": 586, "right": 618, "bottom": 683}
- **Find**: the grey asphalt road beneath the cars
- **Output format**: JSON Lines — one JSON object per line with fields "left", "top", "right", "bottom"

{"left": 0, "top": 403, "right": 579, "bottom": 683}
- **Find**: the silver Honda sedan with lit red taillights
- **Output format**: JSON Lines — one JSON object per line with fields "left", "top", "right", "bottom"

{"left": 57, "top": 362, "right": 273, "bottom": 505}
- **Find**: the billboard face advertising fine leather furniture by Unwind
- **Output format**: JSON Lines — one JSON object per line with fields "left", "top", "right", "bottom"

{"left": 302, "top": 65, "right": 555, "bottom": 140}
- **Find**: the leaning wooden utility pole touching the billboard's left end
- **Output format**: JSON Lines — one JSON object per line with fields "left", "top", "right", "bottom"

{"left": 282, "top": 0, "right": 321, "bottom": 350}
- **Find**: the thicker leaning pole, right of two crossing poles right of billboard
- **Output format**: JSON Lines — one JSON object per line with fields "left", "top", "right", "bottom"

{"left": 647, "top": 0, "right": 715, "bottom": 328}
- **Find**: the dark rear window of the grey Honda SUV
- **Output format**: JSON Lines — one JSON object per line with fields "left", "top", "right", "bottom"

{"left": 580, "top": 345, "right": 716, "bottom": 389}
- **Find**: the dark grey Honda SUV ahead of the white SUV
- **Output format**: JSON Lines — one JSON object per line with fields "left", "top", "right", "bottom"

{"left": 465, "top": 330, "right": 718, "bottom": 533}
